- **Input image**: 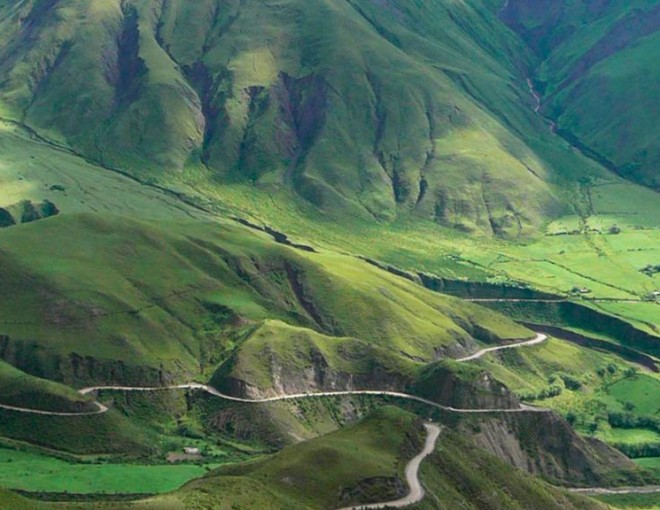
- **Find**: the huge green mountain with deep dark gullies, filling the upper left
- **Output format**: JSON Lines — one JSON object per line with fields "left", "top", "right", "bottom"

{"left": 0, "top": 0, "right": 624, "bottom": 237}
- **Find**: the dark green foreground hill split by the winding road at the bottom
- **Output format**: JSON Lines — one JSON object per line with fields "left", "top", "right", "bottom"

{"left": 3, "top": 408, "right": 605, "bottom": 510}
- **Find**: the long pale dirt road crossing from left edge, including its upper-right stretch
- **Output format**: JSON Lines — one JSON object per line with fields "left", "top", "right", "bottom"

{"left": 0, "top": 333, "right": 548, "bottom": 416}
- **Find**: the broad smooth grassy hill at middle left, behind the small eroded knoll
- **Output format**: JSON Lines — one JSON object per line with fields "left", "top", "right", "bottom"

{"left": 0, "top": 209, "right": 531, "bottom": 385}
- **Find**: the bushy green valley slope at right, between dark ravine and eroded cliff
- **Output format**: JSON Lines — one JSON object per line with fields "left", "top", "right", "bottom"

{"left": 472, "top": 339, "right": 660, "bottom": 457}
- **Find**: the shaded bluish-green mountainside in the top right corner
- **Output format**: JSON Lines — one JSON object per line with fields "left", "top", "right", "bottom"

{"left": 502, "top": 0, "right": 660, "bottom": 190}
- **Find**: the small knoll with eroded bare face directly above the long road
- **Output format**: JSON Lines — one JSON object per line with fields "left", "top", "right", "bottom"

{"left": 212, "top": 321, "right": 518, "bottom": 408}
